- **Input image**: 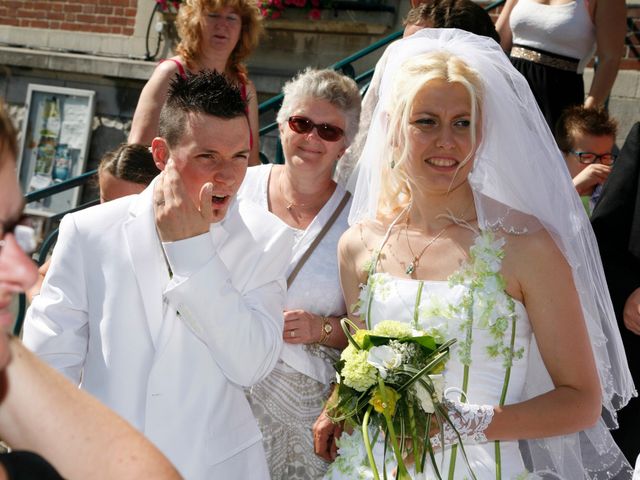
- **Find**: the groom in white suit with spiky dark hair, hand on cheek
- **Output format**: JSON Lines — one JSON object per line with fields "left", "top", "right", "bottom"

{"left": 24, "top": 72, "right": 292, "bottom": 480}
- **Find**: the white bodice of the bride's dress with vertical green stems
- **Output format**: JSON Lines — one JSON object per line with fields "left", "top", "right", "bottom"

{"left": 363, "top": 273, "right": 531, "bottom": 405}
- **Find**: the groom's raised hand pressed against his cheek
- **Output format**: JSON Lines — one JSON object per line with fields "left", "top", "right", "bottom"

{"left": 153, "top": 159, "right": 214, "bottom": 242}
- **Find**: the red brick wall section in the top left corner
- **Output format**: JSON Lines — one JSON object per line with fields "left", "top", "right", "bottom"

{"left": 0, "top": 0, "right": 139, "bottom": 35}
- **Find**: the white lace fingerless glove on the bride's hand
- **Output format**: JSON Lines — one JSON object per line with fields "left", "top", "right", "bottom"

{"left": 431, "top": 398, "right": 493, "bottom": 448}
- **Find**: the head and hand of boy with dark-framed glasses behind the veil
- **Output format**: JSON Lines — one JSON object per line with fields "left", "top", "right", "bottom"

{"left": 555, "top": 106, "right": 618, "bottom": 215}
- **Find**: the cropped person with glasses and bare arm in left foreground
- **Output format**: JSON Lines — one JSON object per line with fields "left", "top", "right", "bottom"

{"left": 0, "top": 99, "right": 180, "bottom": 480}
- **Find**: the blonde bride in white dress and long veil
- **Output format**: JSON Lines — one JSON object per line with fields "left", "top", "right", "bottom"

{"left": 315, "top": 29, "right": 635, "bottom": 479}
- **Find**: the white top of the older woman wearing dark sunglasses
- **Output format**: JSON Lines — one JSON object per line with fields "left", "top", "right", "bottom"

{"left": 238, "top": 164, "right": 351, "bottom": 383}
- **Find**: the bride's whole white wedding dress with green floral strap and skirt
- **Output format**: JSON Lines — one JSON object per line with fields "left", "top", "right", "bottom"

{"left": 325, "top": 232, "right": 533, "bottom": 480}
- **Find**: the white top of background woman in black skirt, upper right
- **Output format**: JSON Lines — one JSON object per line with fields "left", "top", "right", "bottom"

{"left": 509, "top": 0, "right": 606, "bottom": 73}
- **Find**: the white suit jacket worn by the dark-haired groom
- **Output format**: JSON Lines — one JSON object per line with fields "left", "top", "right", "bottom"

{"left": 23, "top": 184, "right": 292, "bottom": 479}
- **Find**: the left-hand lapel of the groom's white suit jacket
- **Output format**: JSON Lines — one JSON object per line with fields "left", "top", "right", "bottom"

{"left": 124, "top": 182, "right": 169, "bottom": 349}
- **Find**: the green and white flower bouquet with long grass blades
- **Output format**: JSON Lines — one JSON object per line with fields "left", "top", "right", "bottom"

{"left": 327, "top": 318, "right": 455, "bottom": 480}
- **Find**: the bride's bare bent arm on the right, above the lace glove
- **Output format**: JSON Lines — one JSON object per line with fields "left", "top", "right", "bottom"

{"left": 485, "top": 232, "right": 601, "bottom": 440}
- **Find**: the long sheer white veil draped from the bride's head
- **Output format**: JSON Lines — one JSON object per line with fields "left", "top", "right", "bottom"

{"left": 349, "top": 29, "right": 635, "bottom": 480}
